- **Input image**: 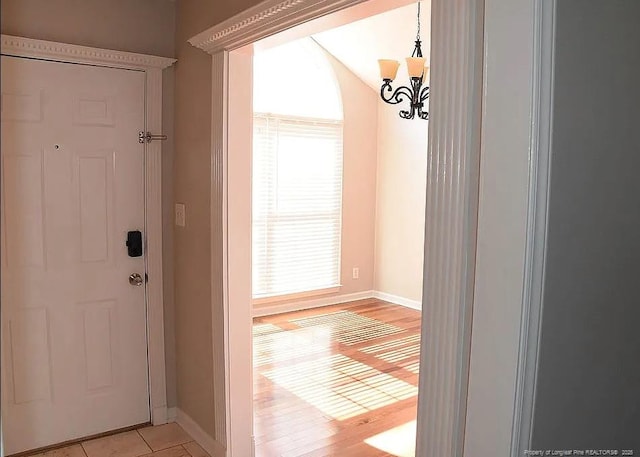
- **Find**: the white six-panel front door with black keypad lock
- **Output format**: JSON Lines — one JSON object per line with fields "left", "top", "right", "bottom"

{"left": 1, "top": 56, "right": 149, "bottom": 454}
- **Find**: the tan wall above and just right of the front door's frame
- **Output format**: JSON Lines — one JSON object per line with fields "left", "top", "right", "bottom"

{"left": 0, "top": 0, "right": 176, "bottom": 407}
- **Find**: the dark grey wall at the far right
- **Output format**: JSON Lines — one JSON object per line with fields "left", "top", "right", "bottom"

{"left": 533, "top": 0, "right": 640, "bottom": 450}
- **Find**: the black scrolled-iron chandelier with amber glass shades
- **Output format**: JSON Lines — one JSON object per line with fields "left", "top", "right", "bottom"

{"left": 378, "top": 1, "right": 429, "bottom": 120}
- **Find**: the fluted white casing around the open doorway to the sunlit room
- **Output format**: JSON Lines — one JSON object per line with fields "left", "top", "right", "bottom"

{"left": 189, "top": 0, "right": 484, "bottom": 457}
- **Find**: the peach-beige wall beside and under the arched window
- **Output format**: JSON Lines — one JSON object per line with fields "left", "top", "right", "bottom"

{"left": 254, "top": 42, "right": 378, "bottom": 310}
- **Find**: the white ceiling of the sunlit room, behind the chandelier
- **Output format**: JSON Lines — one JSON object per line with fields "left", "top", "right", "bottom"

{"left": 313, "top": 0, "right": 431, "bottom": 91}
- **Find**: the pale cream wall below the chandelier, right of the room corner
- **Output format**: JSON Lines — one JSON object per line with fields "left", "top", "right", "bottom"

{"left": 374, "top": 100, "right": 428, "bottom": 305}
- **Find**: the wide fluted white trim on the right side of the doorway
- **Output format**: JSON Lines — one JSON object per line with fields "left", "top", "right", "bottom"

{"left": 416, "top": 0, "right": 484, "bottom": 457}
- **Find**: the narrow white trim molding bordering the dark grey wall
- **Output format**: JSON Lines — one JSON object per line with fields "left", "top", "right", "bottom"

{"left": 510, "top": 0, "right": 557, "bottom": 457}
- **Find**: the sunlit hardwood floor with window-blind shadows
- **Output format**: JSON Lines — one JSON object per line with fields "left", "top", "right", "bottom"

{"left": 253, "top": 299, "right": 420, "bottom": 457}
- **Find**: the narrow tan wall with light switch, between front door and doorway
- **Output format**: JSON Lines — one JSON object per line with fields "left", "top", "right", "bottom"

{"left": 173, "top": 0, "right": 214, "bottom": 436}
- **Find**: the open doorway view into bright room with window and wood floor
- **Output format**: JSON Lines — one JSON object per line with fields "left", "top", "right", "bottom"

{"left": 245, "top": 2, "right": 429, "bottom": 456}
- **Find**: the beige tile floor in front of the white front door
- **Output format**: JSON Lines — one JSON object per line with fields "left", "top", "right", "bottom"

{"left": 30, "top": 423, "right": 209, "bottom": 457}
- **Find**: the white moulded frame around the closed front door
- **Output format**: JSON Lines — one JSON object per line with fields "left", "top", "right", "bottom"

{"left": 0, "top": 34, "right": 176, "bottom": 425}
